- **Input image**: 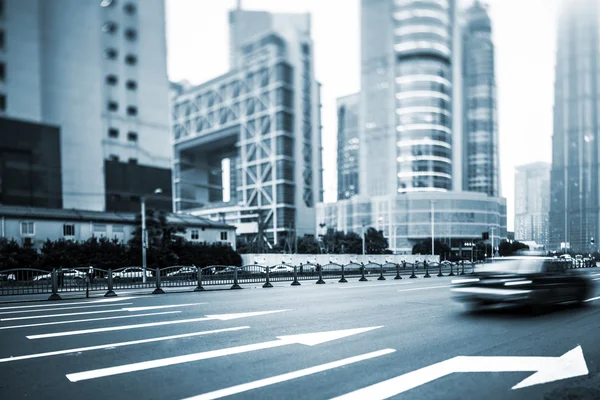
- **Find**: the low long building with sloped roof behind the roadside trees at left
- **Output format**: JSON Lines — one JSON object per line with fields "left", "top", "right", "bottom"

{"left": 0, "top": 206, "right": 236, "bottom": 249}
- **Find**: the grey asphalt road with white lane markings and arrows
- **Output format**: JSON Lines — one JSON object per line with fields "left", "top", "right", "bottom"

{"left": 0, "top": 269, "right": 600, "bottom": 400}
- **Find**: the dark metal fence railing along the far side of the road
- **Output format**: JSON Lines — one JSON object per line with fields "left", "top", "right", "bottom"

{"left": 0, "top": 262, "right": 596, "bottom": 299}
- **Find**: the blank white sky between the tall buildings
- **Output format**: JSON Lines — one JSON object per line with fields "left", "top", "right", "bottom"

{"left": 166, "top": 0, "right": 557, "bottom": 230}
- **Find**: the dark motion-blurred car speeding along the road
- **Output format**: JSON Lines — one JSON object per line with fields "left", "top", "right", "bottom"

{"left": 451, "top": 257, "right": 593, "bottom": 309}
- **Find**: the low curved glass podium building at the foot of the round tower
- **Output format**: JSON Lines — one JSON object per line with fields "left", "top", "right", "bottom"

{"left": 317, "top": 192, "right": 507, "bottom": 256}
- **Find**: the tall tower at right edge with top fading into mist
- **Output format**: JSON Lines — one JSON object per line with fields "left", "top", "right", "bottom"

{"left": 550, "top": 0, "right": 600, "bottom": 252}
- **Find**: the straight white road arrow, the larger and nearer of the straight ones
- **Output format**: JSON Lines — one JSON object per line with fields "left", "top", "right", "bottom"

{"left": 67, "top": 326, "right": 381, "bottom": 382}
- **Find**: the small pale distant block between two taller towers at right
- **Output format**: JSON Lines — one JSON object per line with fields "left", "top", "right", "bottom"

{"left": 515, "top": 162, "right": 551, "bottom": 247}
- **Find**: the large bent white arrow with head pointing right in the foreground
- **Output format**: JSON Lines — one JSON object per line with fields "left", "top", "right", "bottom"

{"left": 334, "top": 346, "right": 588, "bottom": 400}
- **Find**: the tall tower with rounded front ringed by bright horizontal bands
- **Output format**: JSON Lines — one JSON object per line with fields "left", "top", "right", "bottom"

{"left": 359, "top": 0, "right": 455, "bottom": 196}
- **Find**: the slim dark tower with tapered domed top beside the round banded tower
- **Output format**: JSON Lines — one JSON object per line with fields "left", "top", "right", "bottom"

{"left": 461, "top": 0, "right": 500, "bottom": 197}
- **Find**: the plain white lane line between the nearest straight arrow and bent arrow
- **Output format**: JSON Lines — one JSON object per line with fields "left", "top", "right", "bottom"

{"left": 186, "top": 349, "right": 396, "bottom": 400}
